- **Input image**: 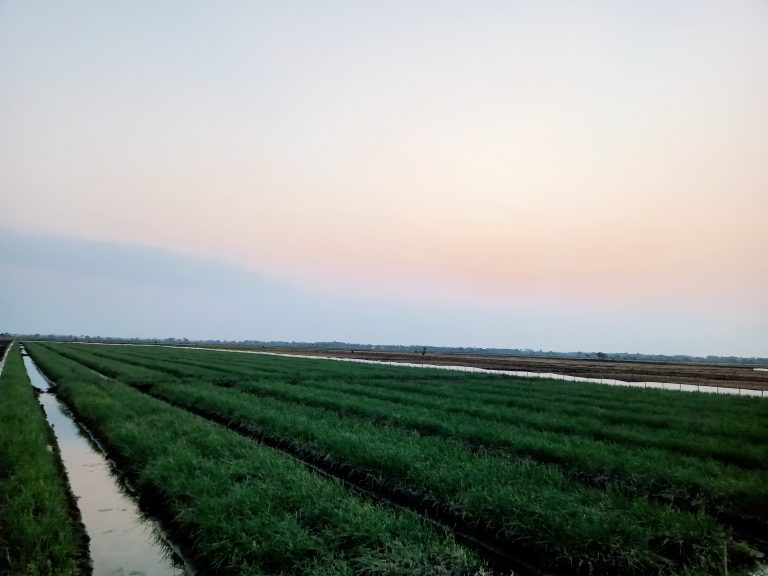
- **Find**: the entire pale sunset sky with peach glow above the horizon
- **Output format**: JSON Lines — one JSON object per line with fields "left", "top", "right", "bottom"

{"left": 0, "top": 0, "right": 768, "bottom": 356}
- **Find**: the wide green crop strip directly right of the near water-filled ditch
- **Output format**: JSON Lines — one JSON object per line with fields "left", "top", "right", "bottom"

{"left": 30, "top": 345, "right": 492, "bottom": 576}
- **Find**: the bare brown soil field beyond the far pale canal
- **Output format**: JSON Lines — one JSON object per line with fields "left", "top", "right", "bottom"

{"left": 222, "top": 346, "right": 768, "bottom": 390}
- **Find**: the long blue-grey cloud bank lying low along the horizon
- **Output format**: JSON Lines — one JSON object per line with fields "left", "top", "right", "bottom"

{"left": 0, "top": 229, "right": 768, "bottom": 356}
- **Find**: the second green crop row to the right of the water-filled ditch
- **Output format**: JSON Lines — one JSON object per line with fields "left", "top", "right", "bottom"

{"left": 33, "top": 344, "right": 727, "bottom": 574}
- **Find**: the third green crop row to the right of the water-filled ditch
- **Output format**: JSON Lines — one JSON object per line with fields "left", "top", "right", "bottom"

{"left": 46, "top": 344, "right": 768, "bottom": 523}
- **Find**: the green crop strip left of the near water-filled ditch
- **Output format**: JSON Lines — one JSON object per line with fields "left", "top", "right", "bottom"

{"left": 0, "top": 345, "right": 90, "bottom": 576}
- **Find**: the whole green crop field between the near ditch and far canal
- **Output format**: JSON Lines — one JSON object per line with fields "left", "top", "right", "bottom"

{"left": 18, "top": 343, "right": 768, "bottom": 576}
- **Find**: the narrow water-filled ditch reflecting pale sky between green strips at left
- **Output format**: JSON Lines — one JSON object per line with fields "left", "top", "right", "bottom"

{"left": 24, "top": 356, "right": 191, "bottom": 576}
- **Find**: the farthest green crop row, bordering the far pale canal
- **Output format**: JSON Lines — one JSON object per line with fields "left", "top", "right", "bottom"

{"left": 67, "top": 346, "right": 768, "bottom": 441}
